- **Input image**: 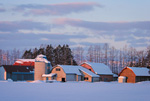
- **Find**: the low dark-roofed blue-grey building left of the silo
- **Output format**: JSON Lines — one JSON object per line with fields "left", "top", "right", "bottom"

{"left": 3, "top": 65, "right": 34, "bottom": 81}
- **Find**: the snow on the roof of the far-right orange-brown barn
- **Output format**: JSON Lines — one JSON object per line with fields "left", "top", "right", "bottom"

{"left": 127, "top": 67, "right": 150, "bottom": 76}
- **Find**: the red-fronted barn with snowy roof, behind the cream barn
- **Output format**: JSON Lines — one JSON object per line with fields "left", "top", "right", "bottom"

{"left": 81, "top": 62, "right": 113, "bottom": 81}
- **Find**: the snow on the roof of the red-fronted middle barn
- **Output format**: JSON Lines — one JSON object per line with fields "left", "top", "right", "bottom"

{"left": 82, "top": 62, "right": 113, "bottom": 75}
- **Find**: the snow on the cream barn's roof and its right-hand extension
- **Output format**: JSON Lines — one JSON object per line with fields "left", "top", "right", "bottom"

{"left": 58, "top": 65, "right": 99, "bottom": 77}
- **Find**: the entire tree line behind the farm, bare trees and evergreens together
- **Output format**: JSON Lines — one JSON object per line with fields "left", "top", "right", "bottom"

{"left": 0, "top": 43, "right": 150, "bottom": 73}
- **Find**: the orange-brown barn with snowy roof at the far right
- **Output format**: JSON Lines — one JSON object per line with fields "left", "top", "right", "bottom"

{"left": 118, "top": 67, "right": 150, "bottom": 83}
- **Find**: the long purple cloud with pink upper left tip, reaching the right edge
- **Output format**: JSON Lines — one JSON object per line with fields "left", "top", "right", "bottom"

{"left": 54, "top": 18, "right": 150, "bottom": 31}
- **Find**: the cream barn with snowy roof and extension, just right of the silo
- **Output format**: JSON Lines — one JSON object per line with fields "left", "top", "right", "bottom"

{"left": 47, "top": 65, "right": 99, "bottom": 82}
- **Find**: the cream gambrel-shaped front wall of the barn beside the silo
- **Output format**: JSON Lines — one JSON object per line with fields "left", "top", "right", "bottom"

{"left": 51, "top": 66, "right": 66, "bottom": 81}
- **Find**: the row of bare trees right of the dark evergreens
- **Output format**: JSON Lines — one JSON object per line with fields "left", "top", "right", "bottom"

{"left": 73, "top": 44, "right": 150, "bottom": 73}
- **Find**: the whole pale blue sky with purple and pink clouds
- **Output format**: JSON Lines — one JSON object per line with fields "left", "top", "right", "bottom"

{"left": 0, "top": 0, "right": 150, "bottom": 50}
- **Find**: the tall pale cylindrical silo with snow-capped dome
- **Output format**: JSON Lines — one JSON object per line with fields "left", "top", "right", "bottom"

{"left": 34, "top": 54, "right": 51, "bottom": 80}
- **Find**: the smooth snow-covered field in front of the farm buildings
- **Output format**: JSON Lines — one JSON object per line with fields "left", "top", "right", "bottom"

{"left": 0, "top": 81, "right": 150, "bottom": 101}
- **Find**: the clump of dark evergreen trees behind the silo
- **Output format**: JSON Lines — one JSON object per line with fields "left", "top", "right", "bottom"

{"left": 22, "top": 45, "right": 77, "bottom": 66}
